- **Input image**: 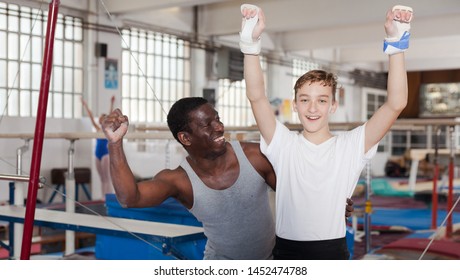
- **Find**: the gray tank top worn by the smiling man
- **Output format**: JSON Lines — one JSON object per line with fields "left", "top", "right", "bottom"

{"left": 181, "top": 141, "right": 275, "bottom": 260}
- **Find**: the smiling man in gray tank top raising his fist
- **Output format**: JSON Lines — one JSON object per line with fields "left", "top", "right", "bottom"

{"left": 102, "top": 97, "right": 351, "bottom": 260}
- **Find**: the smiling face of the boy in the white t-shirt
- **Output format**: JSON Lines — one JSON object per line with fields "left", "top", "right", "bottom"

{"left": 294, "top": 82, "right": 337, "bottom": 133}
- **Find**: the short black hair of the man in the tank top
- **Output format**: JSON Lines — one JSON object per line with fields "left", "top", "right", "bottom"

{"left": 167, "top": 97, "right": 208, "bottom": 143}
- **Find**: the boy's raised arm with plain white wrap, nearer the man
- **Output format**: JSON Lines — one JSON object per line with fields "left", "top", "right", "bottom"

{"left": 240, "top": 4, "right": 276, "bottom": 144}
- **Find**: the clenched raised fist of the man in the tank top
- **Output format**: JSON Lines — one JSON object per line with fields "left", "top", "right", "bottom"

{"left": 101, "top": 109, "right": 129, "bottom": 144}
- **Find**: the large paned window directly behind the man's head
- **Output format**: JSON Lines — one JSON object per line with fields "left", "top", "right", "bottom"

{"left": 122, "top": 28, "right": 191, "bottom": 123}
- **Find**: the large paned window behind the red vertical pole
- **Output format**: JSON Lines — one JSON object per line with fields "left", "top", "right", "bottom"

{"left": 0, "top": 3, "right": 83, "bottom": 118}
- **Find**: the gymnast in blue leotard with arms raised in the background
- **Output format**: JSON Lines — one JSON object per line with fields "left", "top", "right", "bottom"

{"left": 81, "top": 96, "right": 115, "bottom": 200}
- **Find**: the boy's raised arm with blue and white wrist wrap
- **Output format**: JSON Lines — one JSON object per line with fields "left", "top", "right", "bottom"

{"left": 365, "top": 6, "right": 412, "bottom": 152}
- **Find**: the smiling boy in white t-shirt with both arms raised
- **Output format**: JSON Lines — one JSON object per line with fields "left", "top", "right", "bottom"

{"left": 240, "top": 5, "right": 412, "bottom": 259}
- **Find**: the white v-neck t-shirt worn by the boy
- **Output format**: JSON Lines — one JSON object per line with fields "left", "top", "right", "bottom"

{"left": 261, "top": 121, "right": 378, "bottom": 241}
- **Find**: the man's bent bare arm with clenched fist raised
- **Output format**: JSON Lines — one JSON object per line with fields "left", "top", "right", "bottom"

{"left": 102, "top": 109, "right": 177, "bottom": 207}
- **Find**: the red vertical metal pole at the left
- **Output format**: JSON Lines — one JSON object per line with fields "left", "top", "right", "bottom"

{"left": 21, "top": 0, "right": 60, "bottom": 260}
